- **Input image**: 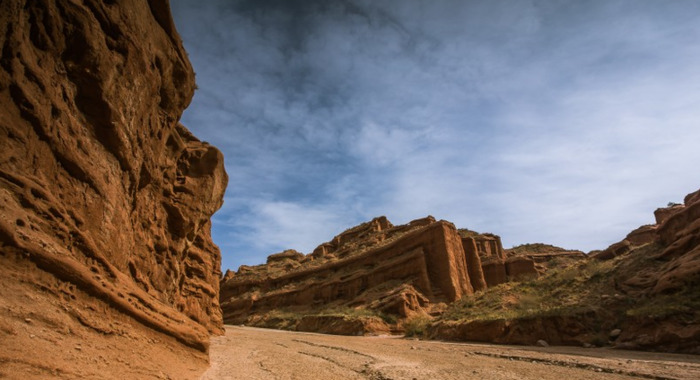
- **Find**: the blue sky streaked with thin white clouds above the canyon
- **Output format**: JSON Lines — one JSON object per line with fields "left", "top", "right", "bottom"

{"left": 171, "top": 0, "right": 700, "bottom": 270}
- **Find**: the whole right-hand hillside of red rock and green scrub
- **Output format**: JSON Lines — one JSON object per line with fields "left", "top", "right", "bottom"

{"left": 429, "top": 191, "right": 700, "bottom": 354}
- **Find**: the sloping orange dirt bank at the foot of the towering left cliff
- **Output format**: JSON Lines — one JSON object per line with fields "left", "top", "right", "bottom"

{"left": 0, "top": 255, "right": 208, "bottom": 380}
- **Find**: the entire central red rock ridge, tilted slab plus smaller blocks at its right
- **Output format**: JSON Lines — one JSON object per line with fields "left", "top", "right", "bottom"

{"left": 221, "top": 216, "right": 564, "bottom": 335}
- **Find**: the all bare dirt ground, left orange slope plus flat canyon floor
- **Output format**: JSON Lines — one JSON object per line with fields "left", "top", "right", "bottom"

{"left": 0, "top": 249, "right": 700, "bottom": 380}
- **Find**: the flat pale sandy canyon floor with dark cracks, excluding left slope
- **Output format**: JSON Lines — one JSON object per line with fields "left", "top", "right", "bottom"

{"left": 202, "top": 326, "right": 700, "bottom": 380}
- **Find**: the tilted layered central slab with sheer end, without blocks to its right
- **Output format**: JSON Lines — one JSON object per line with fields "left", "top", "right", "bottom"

{"left": 221, "top": 217, "right": 483, "bottom": 332}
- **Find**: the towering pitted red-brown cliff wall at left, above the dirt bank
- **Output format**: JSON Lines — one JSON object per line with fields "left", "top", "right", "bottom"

{"left": 0, "top": 0, "right": 227, "bottom": 358}
